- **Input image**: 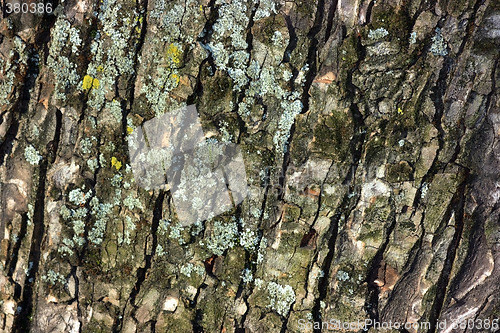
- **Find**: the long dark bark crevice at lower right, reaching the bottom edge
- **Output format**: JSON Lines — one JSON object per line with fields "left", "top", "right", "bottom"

{"left": 427, "top": 169, "right": 469, "bottom": 333}
